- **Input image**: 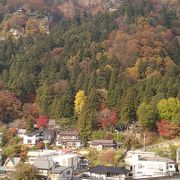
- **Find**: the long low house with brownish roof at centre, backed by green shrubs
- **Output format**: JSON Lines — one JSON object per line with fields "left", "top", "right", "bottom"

{"left": 89, "top": 140, "right": 119, "bottom": 150}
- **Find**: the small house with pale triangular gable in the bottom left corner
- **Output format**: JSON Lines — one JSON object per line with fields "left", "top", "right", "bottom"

{"left": 0, "top": 157, "right": 21, "bottom": 178}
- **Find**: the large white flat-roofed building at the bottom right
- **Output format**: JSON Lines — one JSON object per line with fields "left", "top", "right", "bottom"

{"left": 127, "top": 153, "right": 176, "bottom": 179}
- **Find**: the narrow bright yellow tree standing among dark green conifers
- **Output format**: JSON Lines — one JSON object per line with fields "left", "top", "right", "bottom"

{"left": 74, "top": 90, "right": 86, "bottom": 115}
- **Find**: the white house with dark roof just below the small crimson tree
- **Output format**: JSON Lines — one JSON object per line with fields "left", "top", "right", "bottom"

{"left": 23, "top": 129, "right": 51, "bottom": 146}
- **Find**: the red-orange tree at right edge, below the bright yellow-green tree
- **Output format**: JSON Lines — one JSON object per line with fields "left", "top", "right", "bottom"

{"left": 157, "top": 120, "right": 180, "bottom": 139}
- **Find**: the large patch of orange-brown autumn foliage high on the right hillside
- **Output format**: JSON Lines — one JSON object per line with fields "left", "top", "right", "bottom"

{"left": 106, "top": 17, "right": 174, "bottom": 80}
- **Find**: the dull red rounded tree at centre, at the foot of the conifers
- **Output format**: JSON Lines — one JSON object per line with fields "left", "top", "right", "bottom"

{"left": 98, "top": 108, "right": 118, "bottom": 129}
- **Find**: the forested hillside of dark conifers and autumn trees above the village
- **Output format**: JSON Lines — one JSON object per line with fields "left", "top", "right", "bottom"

{"left": 0, "top": 0, "right": 180, "bottom": 140}
